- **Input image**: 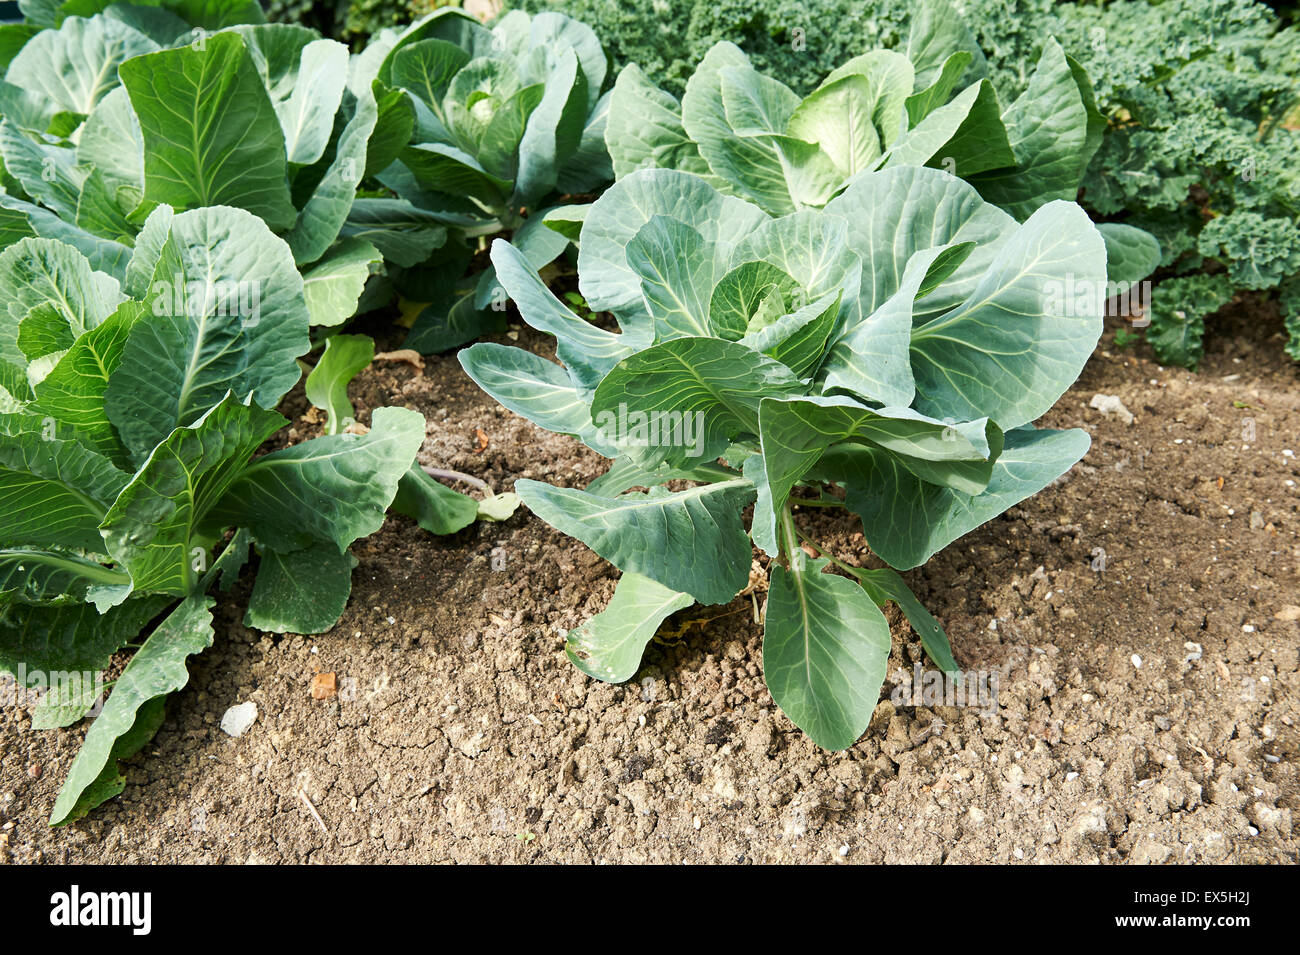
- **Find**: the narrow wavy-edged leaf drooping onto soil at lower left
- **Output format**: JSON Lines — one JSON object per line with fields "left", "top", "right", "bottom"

{"left": 49, "top": 594, "right": 213, "bottom": 825}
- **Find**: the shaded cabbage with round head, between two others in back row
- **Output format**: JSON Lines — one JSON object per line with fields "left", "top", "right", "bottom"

{"left": 348, "top": 9, "right": 612, "bottom": 351}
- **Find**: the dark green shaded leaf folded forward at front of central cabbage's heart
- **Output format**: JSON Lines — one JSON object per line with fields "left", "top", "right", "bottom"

{"left": 592, "top": 338, "right": 803, "bottom": 466}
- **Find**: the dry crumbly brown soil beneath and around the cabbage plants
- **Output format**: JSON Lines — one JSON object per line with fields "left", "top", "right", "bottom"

{"left": 0, "top": 305, "right": 1300, "bottom": 863}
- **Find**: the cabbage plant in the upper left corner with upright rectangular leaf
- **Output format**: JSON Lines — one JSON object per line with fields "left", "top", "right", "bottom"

{"left": 0, "top": 3, "right": 384, "bottom": 325}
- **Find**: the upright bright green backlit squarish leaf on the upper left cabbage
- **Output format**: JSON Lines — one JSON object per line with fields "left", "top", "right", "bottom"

{"left": 120, "top": 34, "right": 298, "bottom": 230}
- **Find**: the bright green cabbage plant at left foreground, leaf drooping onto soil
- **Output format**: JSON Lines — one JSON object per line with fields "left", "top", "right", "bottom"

{"left": 0, "top": 213, "right": 441, "bottom": 824}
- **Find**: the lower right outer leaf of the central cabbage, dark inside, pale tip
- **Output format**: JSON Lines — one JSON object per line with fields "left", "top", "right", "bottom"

{"left": 824, "top": 427, "right": 1089, "bottom": 570}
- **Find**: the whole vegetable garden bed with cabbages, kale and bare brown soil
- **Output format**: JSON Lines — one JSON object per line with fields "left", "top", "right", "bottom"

{"left": 0, "top": 0, "right": 1300, "bottom": 861}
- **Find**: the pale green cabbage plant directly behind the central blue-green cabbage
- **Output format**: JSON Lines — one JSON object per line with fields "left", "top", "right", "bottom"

{"left": 605, "top": 0, "right": 1160, "bottom": 282}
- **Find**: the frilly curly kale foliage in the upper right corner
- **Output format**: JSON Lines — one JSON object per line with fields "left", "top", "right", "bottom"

{"left": 946, "top": 0, "right": 1300, "bottom": 366}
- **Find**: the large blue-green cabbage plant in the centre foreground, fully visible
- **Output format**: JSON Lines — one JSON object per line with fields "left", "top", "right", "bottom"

{"left": 460, "top": 166, "right": 1106, "bottom": 750}
